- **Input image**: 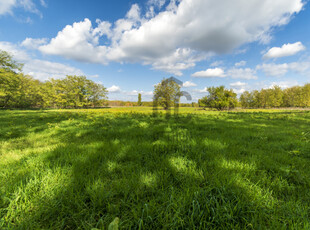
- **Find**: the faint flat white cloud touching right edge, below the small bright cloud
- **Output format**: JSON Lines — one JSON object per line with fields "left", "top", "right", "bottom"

{"left": 256, "top": 62, "right": 310, "bottom": 76}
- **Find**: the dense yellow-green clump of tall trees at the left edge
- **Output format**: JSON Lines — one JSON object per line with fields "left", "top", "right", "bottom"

{"left": 0, "top": 51, "right": 107, "bottom": 108}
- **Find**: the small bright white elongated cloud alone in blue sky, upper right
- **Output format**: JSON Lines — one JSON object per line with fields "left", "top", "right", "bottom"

{"left": 263, "top": 42, "right": 306, "bottom": 59}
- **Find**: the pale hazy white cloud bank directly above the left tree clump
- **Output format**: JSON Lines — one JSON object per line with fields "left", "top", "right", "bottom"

{"left": 0, "top": 42, "right": 85, "bottom": 81}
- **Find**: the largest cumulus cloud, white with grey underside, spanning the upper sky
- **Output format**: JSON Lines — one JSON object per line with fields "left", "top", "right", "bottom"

{"left": 33, "top": 0, "right": 304, "bottom": 75}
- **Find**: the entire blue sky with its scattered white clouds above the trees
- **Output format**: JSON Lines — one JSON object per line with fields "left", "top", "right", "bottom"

{"left": 0, "top": 0, "right": 310, "bottom": 101}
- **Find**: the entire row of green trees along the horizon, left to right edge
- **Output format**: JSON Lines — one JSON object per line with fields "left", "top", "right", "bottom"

{"left": 0, "top": 50, "right": 310, "bottom": 110}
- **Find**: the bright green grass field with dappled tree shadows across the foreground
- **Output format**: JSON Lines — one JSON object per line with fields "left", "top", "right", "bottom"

{"left": 0, "top": 108, "right": 310, "bottom": 229}
